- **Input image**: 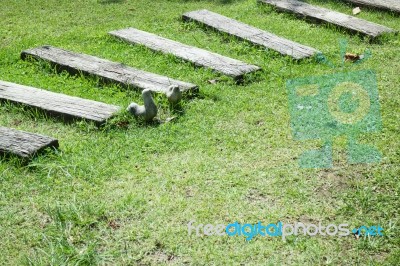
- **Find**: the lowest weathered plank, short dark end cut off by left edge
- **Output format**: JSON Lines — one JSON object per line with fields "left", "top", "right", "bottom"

{"left": 0, "top": 127, "right": 58, "bottom": 158}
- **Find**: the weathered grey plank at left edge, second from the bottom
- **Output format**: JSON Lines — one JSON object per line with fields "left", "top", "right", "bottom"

{"left": 0, "top": 81, "right": 120, "bottom": 123}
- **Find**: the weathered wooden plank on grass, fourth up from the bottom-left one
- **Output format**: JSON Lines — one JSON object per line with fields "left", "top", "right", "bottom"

{"left": 109, "top": 28, "right": 260, "bottom": 79}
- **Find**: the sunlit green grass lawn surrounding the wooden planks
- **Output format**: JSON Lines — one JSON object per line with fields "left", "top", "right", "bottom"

{"left": 0, "top": 0, "right": 400, "bottom": 265}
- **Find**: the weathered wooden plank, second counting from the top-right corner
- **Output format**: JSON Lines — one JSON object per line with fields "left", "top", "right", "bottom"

{"left": 258, "top": 0, "right": 395, "bottom": 38}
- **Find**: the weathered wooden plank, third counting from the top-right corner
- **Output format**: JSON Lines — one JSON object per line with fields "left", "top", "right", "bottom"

{"left": 183, "top": 9, "right": 318, "bottom": 59}
